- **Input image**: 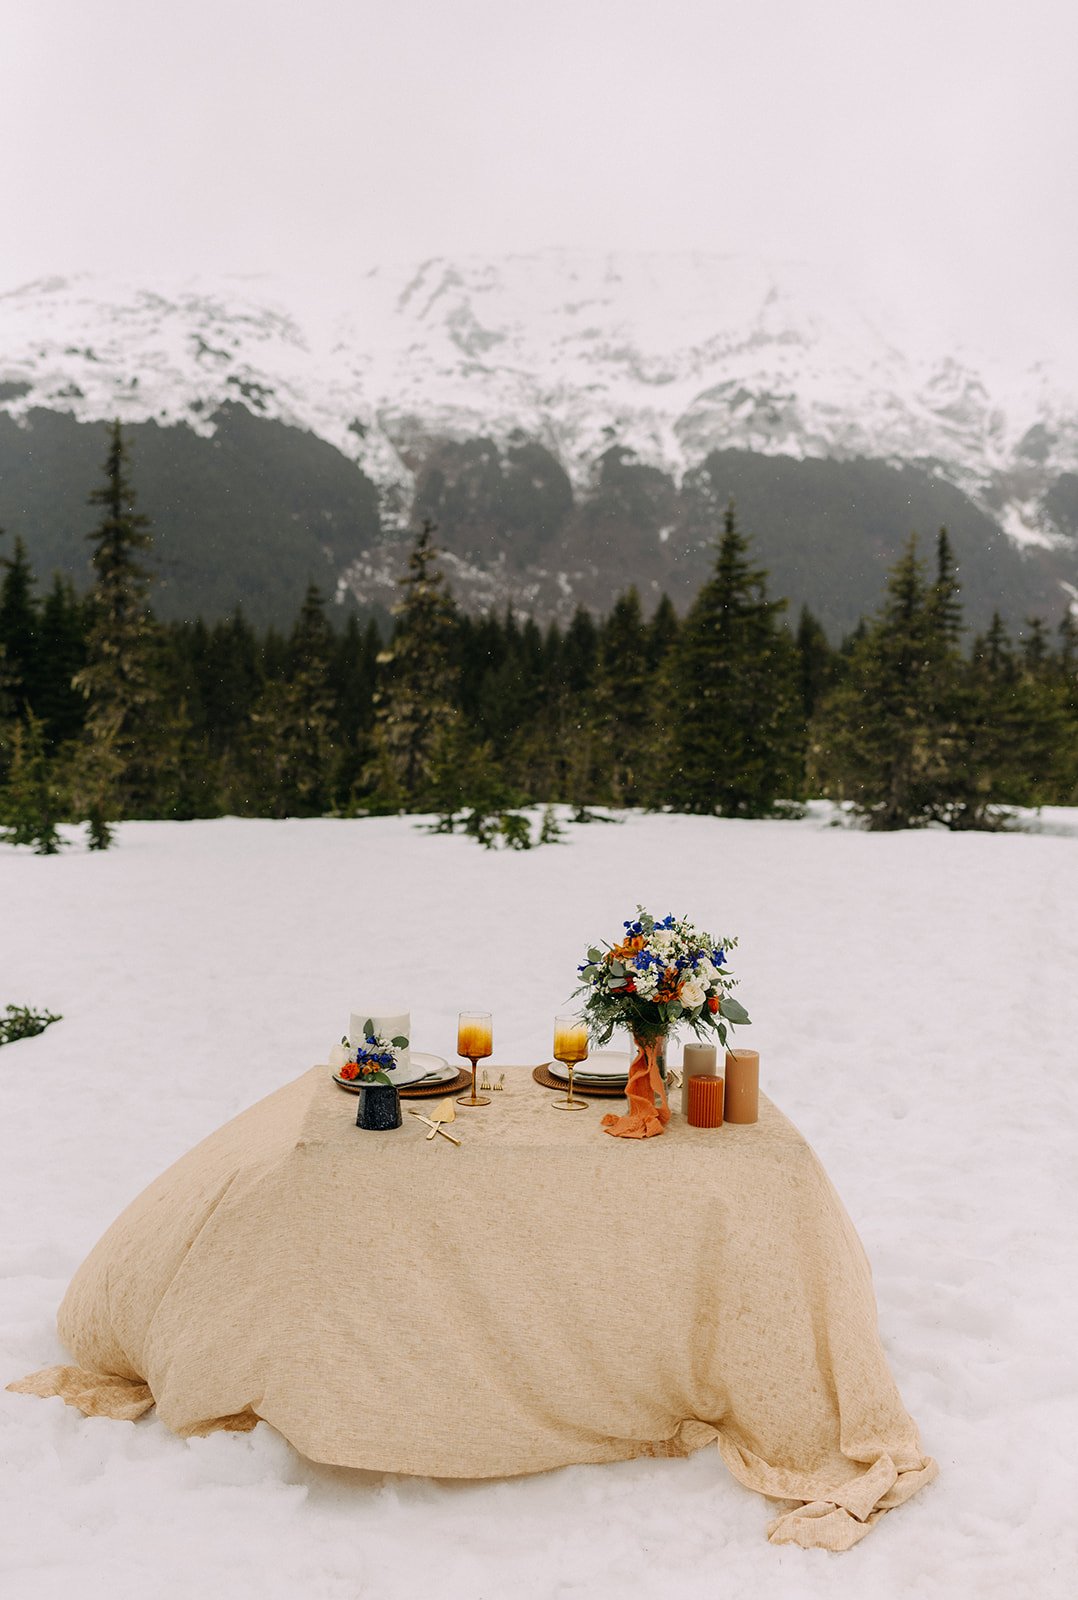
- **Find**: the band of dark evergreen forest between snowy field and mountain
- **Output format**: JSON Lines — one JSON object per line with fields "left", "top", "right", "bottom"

{"left": 0, "top": 424, "right": 1078, "bottom": 853}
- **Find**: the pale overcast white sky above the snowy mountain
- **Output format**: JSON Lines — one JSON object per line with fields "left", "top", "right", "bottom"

{"left": 0, "top": 0, "right": 1078, "bottom": 360}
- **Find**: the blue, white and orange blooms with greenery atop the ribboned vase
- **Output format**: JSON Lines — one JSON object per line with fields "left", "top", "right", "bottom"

{"left": 576, "top": 906, "right": 749, "bottom": 1045}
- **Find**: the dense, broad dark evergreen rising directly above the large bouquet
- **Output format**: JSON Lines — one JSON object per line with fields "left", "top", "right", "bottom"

{"left": 664, "top": 501, "right": 798, "bottom": 816}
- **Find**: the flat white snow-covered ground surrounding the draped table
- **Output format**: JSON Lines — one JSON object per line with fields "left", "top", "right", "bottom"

{"left": 0, "top": 806, "right": 1078, "bottom": 1600}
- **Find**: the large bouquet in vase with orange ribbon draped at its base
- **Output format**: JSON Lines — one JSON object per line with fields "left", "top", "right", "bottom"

{"left": 576, "top": 906, "right": 749, "bottom": 1139}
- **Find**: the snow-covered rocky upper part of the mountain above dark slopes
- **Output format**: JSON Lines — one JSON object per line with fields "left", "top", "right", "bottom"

{"left": 0, "top": 251, "right": 1078, "bottom": 624}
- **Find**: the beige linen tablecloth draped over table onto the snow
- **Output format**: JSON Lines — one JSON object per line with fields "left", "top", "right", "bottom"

{"left": 13, "top": 1067, "right": 936, "bottom": 1549}
